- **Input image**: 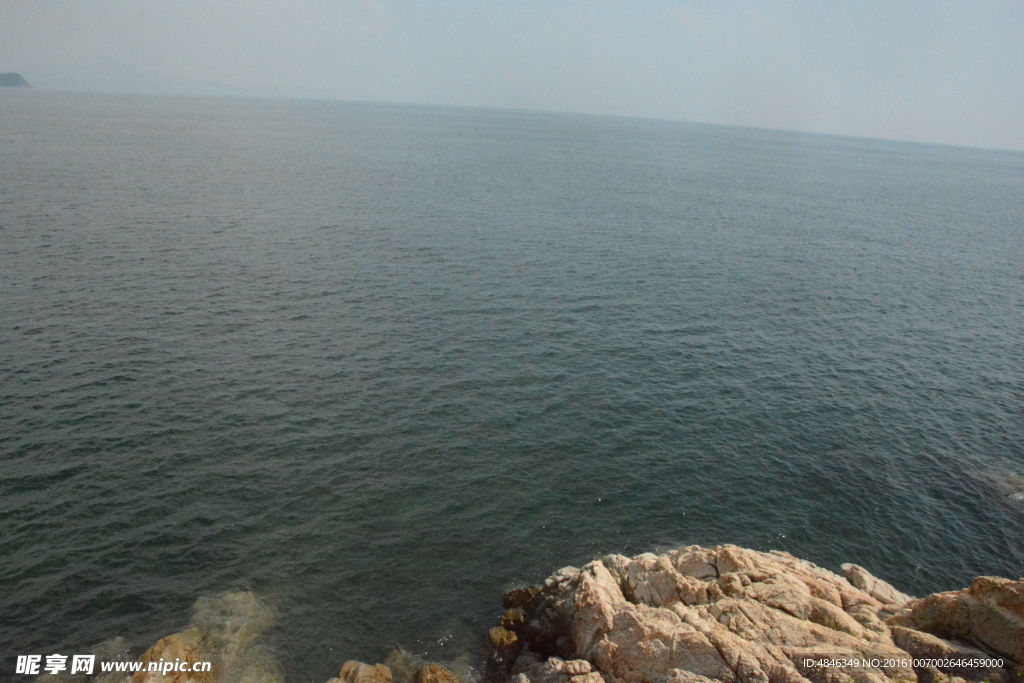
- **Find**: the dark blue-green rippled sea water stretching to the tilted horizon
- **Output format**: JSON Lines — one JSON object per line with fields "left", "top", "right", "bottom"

{"left": 0, "top": 91, "right": 1024, "bottom": 683}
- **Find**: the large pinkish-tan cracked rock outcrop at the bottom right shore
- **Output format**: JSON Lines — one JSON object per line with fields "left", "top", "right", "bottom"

{"left": 487, "top": 546, "right": 1024, "bottom": 683}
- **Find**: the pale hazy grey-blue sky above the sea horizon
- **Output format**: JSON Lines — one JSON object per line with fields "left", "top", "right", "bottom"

{"left": 0, "top": 0, "right": 1024, "bottom": 150}
